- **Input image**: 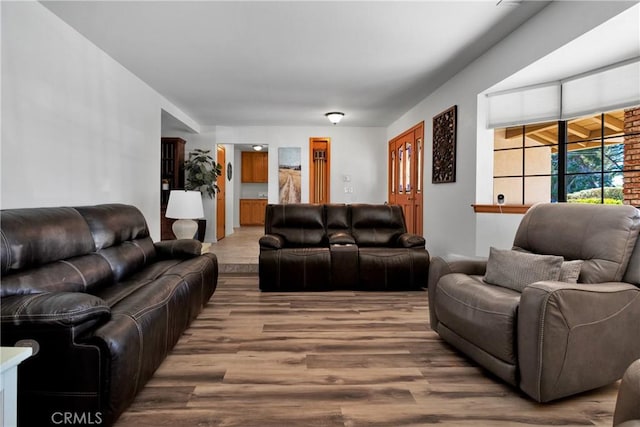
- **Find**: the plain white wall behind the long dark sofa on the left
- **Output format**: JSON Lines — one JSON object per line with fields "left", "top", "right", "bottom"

{"left": 0, "top": 2, "right": 192, "bottom": 240}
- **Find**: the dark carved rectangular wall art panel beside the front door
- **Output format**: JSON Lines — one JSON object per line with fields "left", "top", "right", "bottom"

{"left": 431, "top": 105, "right": 458, "bottom": 184}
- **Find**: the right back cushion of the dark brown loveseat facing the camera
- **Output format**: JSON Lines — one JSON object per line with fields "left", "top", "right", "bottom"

{"left": 351, "top": 204, "right": 407, "bottom": 247}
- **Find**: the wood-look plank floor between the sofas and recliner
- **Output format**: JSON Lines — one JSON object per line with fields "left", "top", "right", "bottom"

{"left": 116, "top": 274, "right": 618, "bottom": 427}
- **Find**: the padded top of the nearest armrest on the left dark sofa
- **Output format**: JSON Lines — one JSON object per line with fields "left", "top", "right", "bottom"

{"left": 0, "top": 292, "right": 111, "bottom": 327}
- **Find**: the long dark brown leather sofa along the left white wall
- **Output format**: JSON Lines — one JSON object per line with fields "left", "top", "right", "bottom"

{"left": 0, "top": 204, "right": 218, "bottom": 426}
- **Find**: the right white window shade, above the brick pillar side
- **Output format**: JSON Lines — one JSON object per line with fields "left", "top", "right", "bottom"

{"left": 561, "top": 58, "right": 640, "bottom": 120}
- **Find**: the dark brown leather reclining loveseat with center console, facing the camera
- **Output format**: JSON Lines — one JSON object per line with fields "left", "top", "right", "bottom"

{"left": 259, "top": 204, "right": 429, "bottom": 291}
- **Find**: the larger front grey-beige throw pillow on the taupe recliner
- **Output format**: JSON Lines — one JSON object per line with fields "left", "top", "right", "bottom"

{"left": 484, "top": 247, "right": 564, "bottom": 292}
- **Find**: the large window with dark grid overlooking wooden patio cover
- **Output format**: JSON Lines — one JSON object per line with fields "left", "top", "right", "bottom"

{"left": 493, "top": 109, "right": 640, "bottom": 205}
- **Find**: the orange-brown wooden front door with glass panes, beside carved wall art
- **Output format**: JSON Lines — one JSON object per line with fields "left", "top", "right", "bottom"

{"left": 388, "top": 122, "right": 424, "bottom": 235}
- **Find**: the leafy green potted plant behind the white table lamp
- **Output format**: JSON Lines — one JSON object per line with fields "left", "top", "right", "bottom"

{"left": 184, "top": 149, "right": 222, "bottom": 242}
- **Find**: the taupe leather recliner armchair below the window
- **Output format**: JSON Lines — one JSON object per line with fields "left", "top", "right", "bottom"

{"left": 428, "top": 203, "right": 640, "bottom": 402}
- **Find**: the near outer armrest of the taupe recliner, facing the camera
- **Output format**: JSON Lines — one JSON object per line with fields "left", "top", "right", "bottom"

{"left": 517, "top": 281, "right": 640, "bottom": 402}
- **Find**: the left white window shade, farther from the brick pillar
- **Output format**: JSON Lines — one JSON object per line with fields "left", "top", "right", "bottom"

{"left": 487, "top": 82, "right": 560, "bottom": 128}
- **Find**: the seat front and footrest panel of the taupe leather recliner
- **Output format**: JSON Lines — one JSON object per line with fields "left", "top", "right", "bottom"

{"left": 431, "top": 273, "right": 521, "bottom": 365}
